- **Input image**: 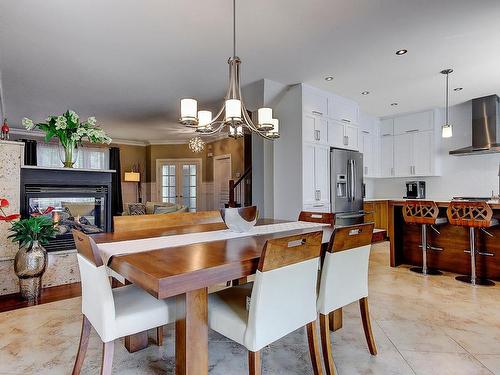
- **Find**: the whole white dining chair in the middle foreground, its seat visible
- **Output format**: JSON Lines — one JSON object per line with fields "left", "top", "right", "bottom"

{"left": 208, "top": 231, "right": 322, "bottom": 375}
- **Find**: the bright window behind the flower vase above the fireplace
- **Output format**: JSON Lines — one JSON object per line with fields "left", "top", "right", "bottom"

{"left": 36, "top": 142, "right": 109, "bottom": 169}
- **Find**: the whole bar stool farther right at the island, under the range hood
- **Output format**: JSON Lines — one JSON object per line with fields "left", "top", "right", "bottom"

{"left": 447, "top": 201, "right": 498, "bottom": 286}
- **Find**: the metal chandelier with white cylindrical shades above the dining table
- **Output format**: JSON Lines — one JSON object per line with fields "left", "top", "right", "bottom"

{"left": 179, "top": 0, "right": 279, "bottom": 139}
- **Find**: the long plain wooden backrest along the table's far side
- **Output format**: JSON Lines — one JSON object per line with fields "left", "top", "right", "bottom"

{"left": 113, "top": 211, "right": 223, "bottom": 233}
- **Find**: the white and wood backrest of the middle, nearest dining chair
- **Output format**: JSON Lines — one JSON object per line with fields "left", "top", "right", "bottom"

{"left": 244, "top": 231, "right": 322, "bottom": 351}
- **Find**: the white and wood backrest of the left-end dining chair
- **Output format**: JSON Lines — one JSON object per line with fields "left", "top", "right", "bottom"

{"left": 73, "top": 230, "right": 115, "bottom": 338}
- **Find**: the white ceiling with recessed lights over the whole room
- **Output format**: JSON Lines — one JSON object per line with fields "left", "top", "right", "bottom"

{"left": 0, "top": 0, "right": 500, "bottom": 141}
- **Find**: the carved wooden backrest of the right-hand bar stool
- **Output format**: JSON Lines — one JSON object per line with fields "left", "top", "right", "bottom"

{"left": 446, "top": 201, "right": 493, "bottom": 228}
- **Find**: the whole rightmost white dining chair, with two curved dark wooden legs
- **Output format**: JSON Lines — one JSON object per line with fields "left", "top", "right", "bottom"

{"left": 317, "top": 223, "right": 377, "bottom": 375}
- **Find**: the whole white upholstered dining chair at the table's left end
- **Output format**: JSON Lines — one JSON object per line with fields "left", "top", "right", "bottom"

{"left": 72, "top": 231, "right": 175, "bottom": 375}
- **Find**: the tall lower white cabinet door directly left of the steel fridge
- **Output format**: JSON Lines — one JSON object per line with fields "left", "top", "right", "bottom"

{"left": 302, "top": 143, "right": 330, "bottom": 212}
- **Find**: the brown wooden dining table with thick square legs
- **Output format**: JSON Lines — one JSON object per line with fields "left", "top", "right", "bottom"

{"left": 93, "top": 219, "right": 330, "bottom": 375}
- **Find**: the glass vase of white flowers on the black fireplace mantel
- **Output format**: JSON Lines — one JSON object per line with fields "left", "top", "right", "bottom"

{"left": 23, "top": 110, "right": 111, "bottom": 168}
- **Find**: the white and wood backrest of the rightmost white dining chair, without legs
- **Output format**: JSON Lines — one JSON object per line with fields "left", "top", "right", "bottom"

{"left": 317, "top": 223, "right": 374, "bottom": 315}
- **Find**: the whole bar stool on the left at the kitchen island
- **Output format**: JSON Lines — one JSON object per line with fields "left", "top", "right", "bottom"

{"left": 403, "top": 200, "right": 448, "bottom": 275}
